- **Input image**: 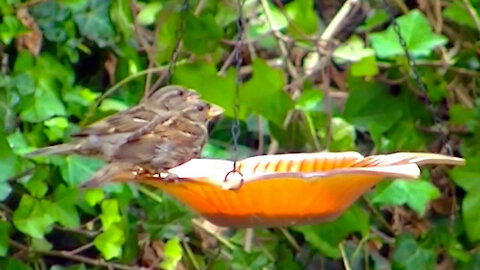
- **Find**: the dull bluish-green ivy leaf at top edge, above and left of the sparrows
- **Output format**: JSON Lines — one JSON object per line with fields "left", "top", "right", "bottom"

{"left": 73, "top": 0, "right": 115, "bottom": 47}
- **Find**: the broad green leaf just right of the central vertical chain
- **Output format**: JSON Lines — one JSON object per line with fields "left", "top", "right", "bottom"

{"left": 240, "top": 59, "right": 293, "bottom": 126}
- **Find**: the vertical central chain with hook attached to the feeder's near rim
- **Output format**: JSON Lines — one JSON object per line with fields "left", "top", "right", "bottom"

{"left": 224, "top": 0, "right": 245, "bottom": 189}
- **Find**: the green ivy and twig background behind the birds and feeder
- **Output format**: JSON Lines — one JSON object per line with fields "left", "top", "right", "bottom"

{"left": 0, "top": 0, "right": 480, "bottom": 270}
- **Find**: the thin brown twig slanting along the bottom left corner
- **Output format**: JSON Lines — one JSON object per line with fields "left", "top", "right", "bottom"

{"left": 10, "top": 239, "right": 146, "bottom": 270}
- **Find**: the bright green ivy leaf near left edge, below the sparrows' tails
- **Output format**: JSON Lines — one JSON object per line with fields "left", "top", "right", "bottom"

{"left": 13, "top": 195, "right": 55, "bottom": 238}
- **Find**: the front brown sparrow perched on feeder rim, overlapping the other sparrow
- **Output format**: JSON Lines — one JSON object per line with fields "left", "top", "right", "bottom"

{"left": 82, "top": 101, "right": 222, "bottom": 187}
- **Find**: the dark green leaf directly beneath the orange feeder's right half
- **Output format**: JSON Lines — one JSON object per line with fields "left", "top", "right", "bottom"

{"left": 292, "top": 205, "right": 370, "bottom": 258}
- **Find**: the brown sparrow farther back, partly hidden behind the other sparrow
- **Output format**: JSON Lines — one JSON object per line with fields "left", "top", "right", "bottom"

{"left": 25, "top": 86, "right": 199, "bottom": 161}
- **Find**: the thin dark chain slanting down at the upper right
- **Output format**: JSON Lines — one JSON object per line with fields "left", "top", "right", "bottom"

{"left": 383, "top": 0, "right": 447, "bottom": 142}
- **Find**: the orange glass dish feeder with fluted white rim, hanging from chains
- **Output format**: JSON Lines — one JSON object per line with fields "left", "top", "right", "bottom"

{"left": 109, "top": 152, "right": 465, "bottom": 227}
